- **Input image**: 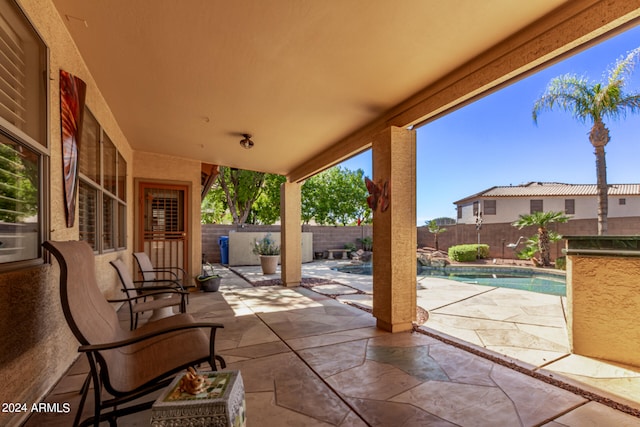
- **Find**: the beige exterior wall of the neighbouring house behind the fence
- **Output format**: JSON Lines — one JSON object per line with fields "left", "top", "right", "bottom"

{"left": 458, "top": 196, "right": 640, "bottom": 224}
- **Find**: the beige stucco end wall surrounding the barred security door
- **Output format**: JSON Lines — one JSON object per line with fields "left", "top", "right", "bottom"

{"left": 129, "top": 151, "right": 202, "bottom": 277}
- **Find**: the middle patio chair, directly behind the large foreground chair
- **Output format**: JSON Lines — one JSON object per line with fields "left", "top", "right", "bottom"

{"left": 109, "top": 259, "right": 188, "bottom": 330}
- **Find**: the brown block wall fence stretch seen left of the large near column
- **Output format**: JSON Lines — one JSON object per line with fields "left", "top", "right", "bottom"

{"left": 202, "top": 224, "right": 373, "bottom": 263}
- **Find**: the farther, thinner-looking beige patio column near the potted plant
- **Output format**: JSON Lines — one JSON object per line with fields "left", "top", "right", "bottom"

{"left": 280, "top": 182, "right": 302, "bottom": 286}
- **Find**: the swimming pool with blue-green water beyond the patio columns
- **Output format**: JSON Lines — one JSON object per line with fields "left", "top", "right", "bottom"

{"left": 336, "top": 264, "right": 567, "bottom": 296}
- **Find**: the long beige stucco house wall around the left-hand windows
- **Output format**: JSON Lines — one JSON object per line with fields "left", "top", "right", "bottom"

{"left": 0, "top": 0, "right": 133, "bottom": 425}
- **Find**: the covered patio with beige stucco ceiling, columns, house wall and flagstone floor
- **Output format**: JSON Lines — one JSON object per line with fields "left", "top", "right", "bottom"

{"left": 0, "top": 0, "right": 640, "bottom": 425}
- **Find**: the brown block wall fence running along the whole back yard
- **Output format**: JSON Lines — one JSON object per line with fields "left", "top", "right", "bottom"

{"left": 202, "top": 216, "right": 640, "bottom": 263}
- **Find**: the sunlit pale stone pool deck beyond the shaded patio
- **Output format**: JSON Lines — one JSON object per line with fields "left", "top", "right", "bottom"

{"left": 232, "top": 260, "right": 640, "bottom": 409}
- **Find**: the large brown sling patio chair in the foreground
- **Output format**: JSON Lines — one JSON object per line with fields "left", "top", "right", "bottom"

{"left": 43, "top": 241, "right": 226, "bottom": 426}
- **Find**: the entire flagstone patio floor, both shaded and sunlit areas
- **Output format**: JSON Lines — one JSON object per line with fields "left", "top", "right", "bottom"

{"left": 25, "top": 261, "right": 640, "bottom": 427}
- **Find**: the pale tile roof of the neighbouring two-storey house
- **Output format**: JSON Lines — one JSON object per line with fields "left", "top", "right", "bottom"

{"left": 454, "top": 182, "right": 640, "bottom": 204}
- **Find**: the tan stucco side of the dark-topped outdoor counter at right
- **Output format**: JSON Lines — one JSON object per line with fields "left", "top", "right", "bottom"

{"left": 567, "top": 255, "right": 640, "bottom": 366}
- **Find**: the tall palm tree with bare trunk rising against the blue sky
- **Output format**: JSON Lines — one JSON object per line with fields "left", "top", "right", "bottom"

{"left": 533, "top": 48, "right": 640, "bottom": 235}
